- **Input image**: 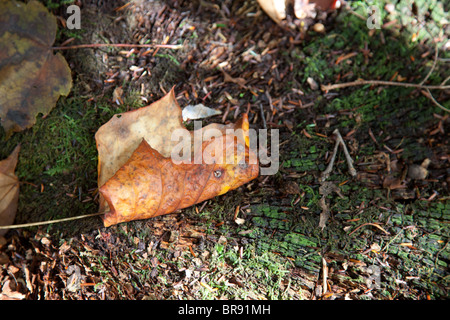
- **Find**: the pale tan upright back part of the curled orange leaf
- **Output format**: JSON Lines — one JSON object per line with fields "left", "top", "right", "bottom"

{"left": 95, "top": 88, "right": 248, "bottom": 211}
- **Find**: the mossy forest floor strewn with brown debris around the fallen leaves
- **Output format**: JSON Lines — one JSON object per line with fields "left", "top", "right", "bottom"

{"left": 0, "top": 0, "right": 450, "bottom": 300}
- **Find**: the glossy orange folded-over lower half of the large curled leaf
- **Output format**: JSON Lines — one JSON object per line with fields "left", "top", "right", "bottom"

{"left": 99, "top": 136, "right": 259, "bottom": 227}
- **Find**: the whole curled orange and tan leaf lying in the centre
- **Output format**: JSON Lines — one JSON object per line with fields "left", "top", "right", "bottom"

{"left": 96, "top": 89, "right": 259, "bottom": 226}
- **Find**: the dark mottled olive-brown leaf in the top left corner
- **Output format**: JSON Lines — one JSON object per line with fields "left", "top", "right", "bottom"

{"left": 0, "top": 1, "right": 72, "bottom": 138}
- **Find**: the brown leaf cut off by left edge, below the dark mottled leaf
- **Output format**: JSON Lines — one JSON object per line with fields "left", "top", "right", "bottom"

{"left": 0, "top": 145, "right": 20, "bottom": 236}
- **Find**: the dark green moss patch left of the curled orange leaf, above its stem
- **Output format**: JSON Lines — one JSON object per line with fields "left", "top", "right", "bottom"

{"left": 0, "top": 88, "right": 140, "bottom": 231}
